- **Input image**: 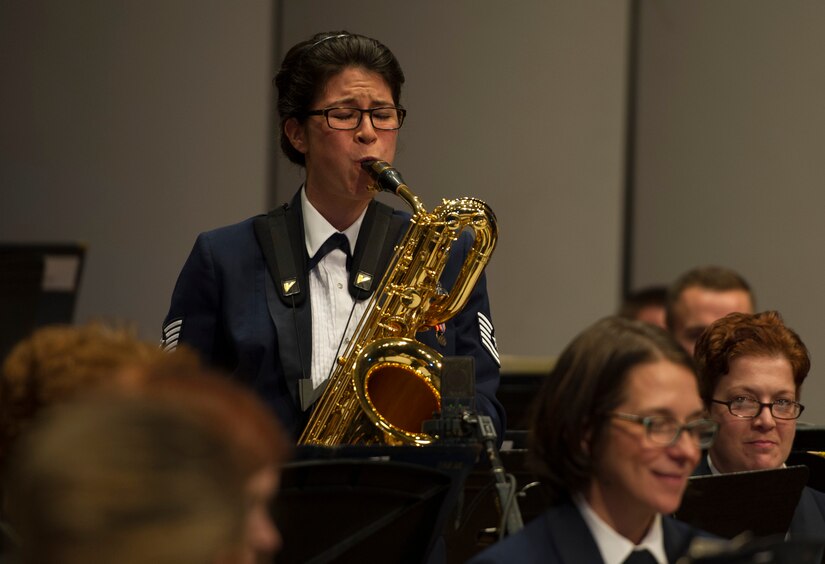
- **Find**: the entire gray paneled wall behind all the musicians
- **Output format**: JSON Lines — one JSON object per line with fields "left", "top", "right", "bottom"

{"left": 0, "top": 0, "right": 825, "bottom": 420}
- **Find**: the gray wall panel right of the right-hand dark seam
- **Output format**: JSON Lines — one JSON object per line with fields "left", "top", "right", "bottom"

{"left": 632, "top": 0, "right": 825, "bottom": 423}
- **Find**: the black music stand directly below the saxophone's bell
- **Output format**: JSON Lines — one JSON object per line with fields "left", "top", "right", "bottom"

{"left": 274, "top": 445, "right": 479, "bottom": 564}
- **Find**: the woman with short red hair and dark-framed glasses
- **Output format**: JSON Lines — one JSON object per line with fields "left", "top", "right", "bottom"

{"left": 695, "top": 311, "right": 825, "bottom": 540}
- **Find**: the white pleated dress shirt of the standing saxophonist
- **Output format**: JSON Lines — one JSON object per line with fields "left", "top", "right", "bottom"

{"left": 301, "top": 188, "right": 369, "bottom": 388}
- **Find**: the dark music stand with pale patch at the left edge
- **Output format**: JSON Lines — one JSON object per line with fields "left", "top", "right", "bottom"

{"left": 0, "top": 243, "right": 86, "bottom": 360}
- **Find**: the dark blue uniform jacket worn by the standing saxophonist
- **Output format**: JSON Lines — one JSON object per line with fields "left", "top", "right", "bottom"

{"left": 163, "top": 194, "right": 504, "bottom": 441}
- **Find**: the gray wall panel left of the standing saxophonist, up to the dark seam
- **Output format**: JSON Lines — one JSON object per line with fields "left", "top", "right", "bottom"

{"left": 0, "top": 0, "right": 273, "bottom": 339}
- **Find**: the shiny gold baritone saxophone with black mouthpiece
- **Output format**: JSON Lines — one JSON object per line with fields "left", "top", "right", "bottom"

{"left": 298, "top": 161, "right": 498, "bottom": 446}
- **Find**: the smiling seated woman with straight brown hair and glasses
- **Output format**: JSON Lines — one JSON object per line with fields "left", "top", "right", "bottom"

{"left": 471, "top": 318, "right": 715, "bottom": 564}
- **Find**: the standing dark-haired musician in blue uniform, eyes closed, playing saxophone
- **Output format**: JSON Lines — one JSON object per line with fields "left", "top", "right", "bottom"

{"left": 158, "top": 32, "right": 504, "bottom": 437}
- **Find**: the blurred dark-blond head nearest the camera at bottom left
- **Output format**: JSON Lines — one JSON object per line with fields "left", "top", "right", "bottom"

{"left": 6, "top": 394, "right": 245, "bottom": 564}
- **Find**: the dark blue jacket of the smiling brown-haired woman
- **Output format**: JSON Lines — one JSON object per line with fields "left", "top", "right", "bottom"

{"left": 469, "top": 502, "right": 707, "bottom": 564}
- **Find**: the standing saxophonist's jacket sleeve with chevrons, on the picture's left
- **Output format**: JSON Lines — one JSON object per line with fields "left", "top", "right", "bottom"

{"left": 161, "top": 233, "right": 230, "bottom": 368}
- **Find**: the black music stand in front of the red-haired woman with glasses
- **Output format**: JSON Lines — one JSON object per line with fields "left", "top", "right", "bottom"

{"left": 675, "top": 466, "right": 808, "bottom": 539}
